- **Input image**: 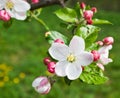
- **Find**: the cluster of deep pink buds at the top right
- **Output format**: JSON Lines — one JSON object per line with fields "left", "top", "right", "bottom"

{"left": 80, "top": 2, "right": 97, "bottom": 24}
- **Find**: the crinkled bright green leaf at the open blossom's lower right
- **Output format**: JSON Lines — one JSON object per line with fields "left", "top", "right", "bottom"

{"left": 80, "top": 65, "right": 108, "bottom": 85}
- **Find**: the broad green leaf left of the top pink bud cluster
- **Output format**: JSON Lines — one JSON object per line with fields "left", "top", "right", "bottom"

{"left": 55, "top": 7, "right": 77, "bottom": 23}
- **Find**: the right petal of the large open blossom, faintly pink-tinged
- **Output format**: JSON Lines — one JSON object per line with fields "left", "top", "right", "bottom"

{"left": 76, "top": 52, "right": 93, "bottom": 66}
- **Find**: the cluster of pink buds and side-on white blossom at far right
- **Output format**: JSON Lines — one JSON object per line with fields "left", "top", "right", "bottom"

{"left": 91, "top": 37, "right": 114, "bottom": 70}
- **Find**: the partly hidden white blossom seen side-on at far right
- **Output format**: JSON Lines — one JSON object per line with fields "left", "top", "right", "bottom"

{"left": 97, "top": 45, "right": 112, "bottom": 70}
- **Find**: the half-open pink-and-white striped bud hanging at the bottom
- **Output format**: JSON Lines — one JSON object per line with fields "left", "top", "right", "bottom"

{"left": 32, "top": 76, "right": 51, "bottom": 94}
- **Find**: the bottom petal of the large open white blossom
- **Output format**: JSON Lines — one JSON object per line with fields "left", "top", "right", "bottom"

{"left": 66, "top": 63, "right": 82, "bottom": 80}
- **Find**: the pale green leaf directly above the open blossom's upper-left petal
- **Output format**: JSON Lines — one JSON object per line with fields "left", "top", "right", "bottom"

{"left": 46, "top": 31, "right": 67, "bottom": 44}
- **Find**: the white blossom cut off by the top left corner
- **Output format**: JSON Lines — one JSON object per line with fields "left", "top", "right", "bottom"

{"left": 0, "top": 0, "right": 30, "bottom": 20}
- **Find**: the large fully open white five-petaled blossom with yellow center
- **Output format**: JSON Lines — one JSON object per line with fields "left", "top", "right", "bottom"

{"left": 49, "top": 36, "right": 93, "bottom": 80}
